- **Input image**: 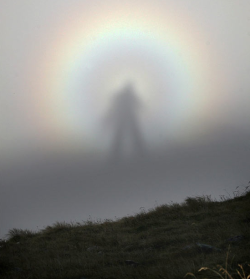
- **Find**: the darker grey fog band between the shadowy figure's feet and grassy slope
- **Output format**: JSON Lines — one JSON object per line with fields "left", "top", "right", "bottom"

{"left": 0, "top": 128, "right": 250, "bottom": 240}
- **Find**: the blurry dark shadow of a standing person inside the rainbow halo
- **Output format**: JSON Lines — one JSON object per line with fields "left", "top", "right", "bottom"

{"left": 105, "top": 83, "right": 145, "bottom": 159}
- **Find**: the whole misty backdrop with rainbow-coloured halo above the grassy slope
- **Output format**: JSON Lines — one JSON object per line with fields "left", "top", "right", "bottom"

{"left": 0, "top": 0, "right": 250, "bottom": 240}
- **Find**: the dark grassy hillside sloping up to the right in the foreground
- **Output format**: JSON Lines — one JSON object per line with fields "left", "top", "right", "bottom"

{"left": 0, "top": 190, "right": 250, "bottom": 279}
